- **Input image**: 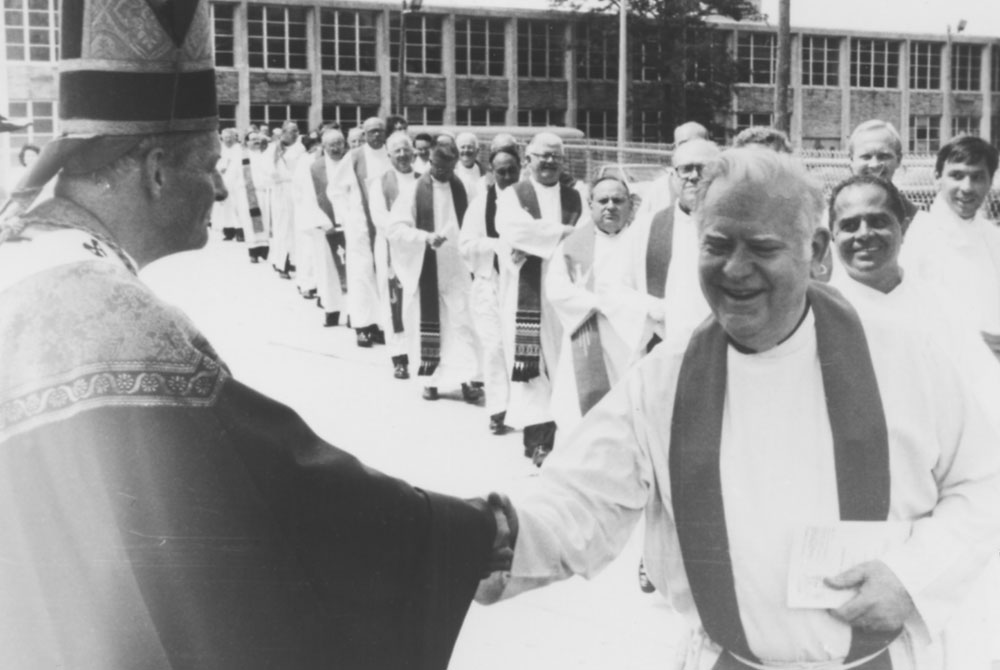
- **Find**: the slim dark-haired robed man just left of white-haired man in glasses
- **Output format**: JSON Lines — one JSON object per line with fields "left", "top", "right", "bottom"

{"left": 458, "top": 146, "right": 521, "bottom": 435}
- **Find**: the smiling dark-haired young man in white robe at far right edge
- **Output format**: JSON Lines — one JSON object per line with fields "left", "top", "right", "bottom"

{"left": 901, "top": 135, "right": 1000, "bottom": 358}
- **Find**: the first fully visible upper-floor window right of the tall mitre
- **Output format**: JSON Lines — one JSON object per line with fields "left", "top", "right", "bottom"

{"left": 247, "top": 5, "right": 308, "bottom": 70}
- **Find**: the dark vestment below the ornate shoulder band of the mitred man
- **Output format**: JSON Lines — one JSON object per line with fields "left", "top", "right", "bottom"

{"left": 0, "top": 380, "right": 495, "bottom": 670}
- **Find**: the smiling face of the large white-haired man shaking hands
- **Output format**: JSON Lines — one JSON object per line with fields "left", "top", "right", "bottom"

{"left": 698, "top": 177, "right": 829, "bottom": 351}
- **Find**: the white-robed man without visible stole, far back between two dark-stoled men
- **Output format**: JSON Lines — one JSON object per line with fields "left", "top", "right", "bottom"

{"left": 264, "top": 121, "right": 306, "bottom": 279}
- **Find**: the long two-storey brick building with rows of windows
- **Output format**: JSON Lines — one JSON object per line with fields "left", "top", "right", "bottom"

{"left": 0, "top": 0, "right": 1000, "bottom": 183}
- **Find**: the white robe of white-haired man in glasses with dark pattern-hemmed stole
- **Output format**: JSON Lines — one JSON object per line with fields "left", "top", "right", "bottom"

{"left": 496, "top": 178, "right": 584, "bottom": 428}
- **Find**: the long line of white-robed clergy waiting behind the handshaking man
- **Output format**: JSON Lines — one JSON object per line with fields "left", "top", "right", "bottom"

{"left": 212, "top": 117, "right": 1000, "bottom": 464}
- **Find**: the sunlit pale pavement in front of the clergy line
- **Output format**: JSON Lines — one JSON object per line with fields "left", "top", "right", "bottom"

{"left": 143, "top": 233, "right": 681, "bottom": 670}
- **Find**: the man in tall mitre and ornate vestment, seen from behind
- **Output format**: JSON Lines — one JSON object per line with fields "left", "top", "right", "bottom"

{"left": 0, "top": 0, "right": 504, "bottom": 670}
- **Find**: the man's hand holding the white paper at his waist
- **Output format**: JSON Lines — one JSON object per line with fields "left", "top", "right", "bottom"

{"left": 824, "top": 561, "right": 916, "bottom": 633}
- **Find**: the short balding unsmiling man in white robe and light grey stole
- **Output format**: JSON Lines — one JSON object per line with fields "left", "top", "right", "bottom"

{"left": 545, "top": 177, "right": 647, "bottom": 442}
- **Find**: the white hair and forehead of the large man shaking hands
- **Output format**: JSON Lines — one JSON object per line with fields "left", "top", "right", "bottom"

{"left": 695, "top": 147, "right": 823, "bottom": 242}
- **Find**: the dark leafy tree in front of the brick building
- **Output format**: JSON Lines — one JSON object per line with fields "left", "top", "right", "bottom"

{"left": 550, "top": 0, "right": 760, "bottom": 138}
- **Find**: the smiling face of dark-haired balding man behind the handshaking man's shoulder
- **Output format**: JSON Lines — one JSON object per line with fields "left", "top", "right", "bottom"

{"left": 830, "top": 184, "right": 903, "bottom": 293}
